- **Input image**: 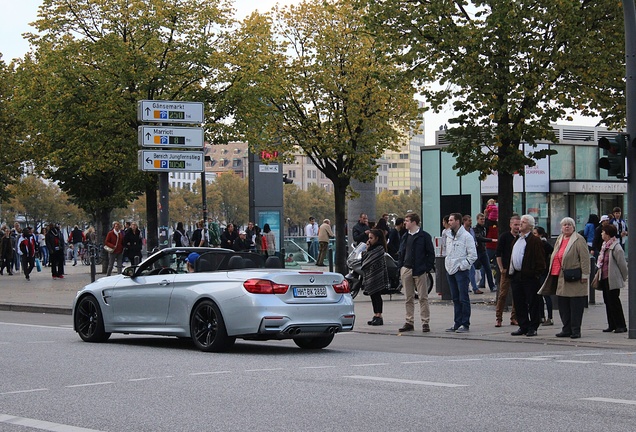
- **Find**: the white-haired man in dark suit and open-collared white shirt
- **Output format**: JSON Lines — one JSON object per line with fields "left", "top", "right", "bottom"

{"left": 508, "top": 215, "right": 545, "bottom": 336}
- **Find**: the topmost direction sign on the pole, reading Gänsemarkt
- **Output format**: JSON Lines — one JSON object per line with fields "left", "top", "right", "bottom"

{"left": 137, "top": 100, "right": 203, "bottom": 124}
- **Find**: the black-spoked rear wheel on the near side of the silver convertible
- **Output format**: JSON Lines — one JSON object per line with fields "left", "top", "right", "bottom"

{"left": 190, "top": 300, "right": 236, "bottom": 352}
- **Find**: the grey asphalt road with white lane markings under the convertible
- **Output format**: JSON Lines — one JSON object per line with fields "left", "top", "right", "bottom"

{"left": 0, "top": 312, "right": 636, "bottom": 432}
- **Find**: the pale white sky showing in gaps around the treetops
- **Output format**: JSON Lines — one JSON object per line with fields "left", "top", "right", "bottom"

{"left": 0, "top": 0, "right": 595, "bottom": 145}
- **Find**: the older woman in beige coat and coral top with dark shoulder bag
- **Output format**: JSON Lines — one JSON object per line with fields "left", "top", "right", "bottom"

{"left": 539, "top": 217, "right": 590, "bottom": 339}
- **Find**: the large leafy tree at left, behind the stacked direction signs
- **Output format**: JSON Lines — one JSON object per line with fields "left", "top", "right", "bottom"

{"left": 16, "top": 0, "right": 238, "bottom": 247}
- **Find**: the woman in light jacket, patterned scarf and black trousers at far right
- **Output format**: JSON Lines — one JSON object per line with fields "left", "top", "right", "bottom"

{"left": 592, "top": 224, "right": 627, "bottom": 333}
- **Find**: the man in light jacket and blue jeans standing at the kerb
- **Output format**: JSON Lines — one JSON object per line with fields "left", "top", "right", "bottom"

{"left": 444, "top": 213, "right": 477, "bottom": 333}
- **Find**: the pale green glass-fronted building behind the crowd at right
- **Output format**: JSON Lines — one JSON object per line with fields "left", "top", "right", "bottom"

{"left": 421, "top": 125, "right": 627, "bottom": 245}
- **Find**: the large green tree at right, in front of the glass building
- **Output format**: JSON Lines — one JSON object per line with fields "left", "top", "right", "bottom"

{"left": 361, "top": 0, "right": 625, "bottom": 228}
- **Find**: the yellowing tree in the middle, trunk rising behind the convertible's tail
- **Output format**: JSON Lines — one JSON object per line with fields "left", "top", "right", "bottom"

{"left": 235, "top": 0, "right": 418, "bottom": 272}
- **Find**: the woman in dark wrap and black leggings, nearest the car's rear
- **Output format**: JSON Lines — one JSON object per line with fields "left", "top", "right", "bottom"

{"left": 362, "top": 229, "right": 389, "bottom": 326}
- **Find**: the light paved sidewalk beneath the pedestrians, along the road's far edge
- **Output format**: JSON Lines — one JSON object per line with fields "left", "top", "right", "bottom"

{"left": 0, "top": 262, "right": 636, "bottom": 350}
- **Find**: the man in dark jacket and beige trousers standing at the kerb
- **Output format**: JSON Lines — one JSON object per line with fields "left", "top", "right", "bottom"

{"left": 398, "top": 213, "right": 435, "bottom": 333}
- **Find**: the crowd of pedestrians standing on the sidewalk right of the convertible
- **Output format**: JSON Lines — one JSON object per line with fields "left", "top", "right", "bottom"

{"left": 352, "top": 200, "right": 628, "bottom": 339}
